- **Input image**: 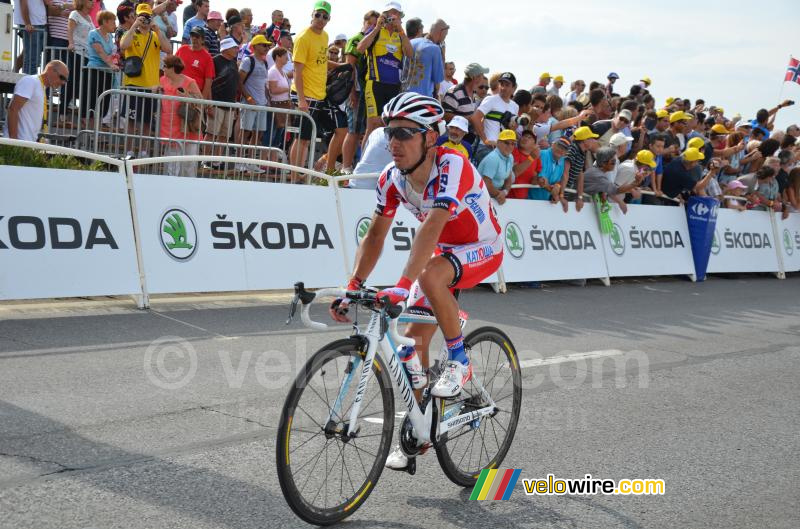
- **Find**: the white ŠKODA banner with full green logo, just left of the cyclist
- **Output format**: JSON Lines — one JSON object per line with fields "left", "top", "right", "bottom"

{"left": 133, "top": 175, "right": 345, "bottom": 294}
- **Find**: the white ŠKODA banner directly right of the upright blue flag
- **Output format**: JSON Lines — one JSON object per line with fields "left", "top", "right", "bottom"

{"left": 708, "top": 209, "right": 780, "bottom": 274}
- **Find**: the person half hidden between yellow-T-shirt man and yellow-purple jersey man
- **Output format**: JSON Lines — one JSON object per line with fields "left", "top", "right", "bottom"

{"left": 342, "top": 10, "right": 380, "bottom": 174}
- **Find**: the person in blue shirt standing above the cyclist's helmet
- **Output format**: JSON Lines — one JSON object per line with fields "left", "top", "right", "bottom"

{"left": 404, "top": 19, "right": 450, "bottom": 99}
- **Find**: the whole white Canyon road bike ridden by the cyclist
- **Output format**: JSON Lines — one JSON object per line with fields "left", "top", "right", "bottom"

{"left": 276, "top": 283, "right": 522, "bottom": 525}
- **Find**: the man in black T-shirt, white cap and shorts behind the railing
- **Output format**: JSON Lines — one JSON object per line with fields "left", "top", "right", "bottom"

{"left": 203, "top": 37, "right": 239, "bottom": 166}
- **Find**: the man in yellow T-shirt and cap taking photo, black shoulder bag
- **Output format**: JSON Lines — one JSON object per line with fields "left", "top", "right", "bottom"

{"left": 119, "top": 4, "right": 171, "bottom": 156}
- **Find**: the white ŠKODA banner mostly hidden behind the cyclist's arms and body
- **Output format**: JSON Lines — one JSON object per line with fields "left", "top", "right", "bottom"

{"left": 340, "top": 189, "right": 500, "bottom": 286}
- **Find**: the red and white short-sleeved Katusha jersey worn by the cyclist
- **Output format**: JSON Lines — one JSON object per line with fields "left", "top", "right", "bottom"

{"left": 376, "top": 147, "right": 500, "bottom": 243}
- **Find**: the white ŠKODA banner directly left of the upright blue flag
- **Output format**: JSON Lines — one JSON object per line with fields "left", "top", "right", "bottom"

{"left": 603, "top": 204, "right": 694, "bottom": 277}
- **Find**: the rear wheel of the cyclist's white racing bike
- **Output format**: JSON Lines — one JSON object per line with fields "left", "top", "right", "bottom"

{"left": 435, "top": 327, "right": 522, "bottom": 487}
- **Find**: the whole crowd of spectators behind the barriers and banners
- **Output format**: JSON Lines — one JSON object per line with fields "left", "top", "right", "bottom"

{"left": 6, "top": 0, "right": 800, "bottom": 212}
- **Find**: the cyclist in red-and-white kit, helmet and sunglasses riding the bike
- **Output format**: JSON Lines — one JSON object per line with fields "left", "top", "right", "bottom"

{"left": 330, "top": 92, "right": 503, "bottom": 470}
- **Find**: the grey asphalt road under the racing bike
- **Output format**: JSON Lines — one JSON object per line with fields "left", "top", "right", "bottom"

{"left": 0, "top": 276, "right": 800, "bottom": 529}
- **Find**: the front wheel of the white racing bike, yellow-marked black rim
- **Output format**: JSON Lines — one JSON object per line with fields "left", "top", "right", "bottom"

{"left": 276, "top": 338, "right": 394, "bottom": 525}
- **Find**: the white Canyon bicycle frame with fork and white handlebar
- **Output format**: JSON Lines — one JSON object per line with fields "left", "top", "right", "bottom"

{"left": 300, "top": 288, "right": 497, "bottom": 445}
